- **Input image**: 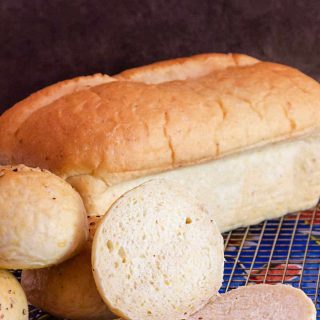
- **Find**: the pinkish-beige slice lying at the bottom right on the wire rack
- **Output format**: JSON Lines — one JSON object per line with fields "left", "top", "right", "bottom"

{"left": 189, "top": 284, "right": 316, "bottom": 320}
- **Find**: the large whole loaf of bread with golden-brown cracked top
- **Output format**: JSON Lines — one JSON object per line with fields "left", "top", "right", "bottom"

{"left": 0, "top": 54, "right": 320, "bottom": 231}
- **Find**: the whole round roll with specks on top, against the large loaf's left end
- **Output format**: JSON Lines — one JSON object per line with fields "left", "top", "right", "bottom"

{"left": 0, "top": 165, "right": 88, "bottom": 269}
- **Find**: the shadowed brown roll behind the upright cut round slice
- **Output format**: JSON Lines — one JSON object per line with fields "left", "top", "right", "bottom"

{"left": 21, "top": 243, "right": 116, "bottom": 320}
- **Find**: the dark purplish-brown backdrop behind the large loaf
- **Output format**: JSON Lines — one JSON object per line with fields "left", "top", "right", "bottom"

{"left": 0, "top": 0, "right": 320, "bottom": 113}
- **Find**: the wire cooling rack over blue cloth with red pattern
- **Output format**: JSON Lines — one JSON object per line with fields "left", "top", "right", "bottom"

{"left": 29, "top": 204, "right": 320, "bottom": 320}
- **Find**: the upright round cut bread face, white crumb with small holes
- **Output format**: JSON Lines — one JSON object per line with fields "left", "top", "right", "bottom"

{"left": 92, "top": 180, "right": 223, "bottom": 320}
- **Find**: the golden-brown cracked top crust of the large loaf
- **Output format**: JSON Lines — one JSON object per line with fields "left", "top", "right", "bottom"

{"left": 0, "top": 54, "right": 320, "bottom": 185}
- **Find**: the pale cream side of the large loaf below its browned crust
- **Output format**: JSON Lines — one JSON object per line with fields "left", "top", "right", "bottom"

{"left": 68, "top": 136, "right": 320, "bottom": 232}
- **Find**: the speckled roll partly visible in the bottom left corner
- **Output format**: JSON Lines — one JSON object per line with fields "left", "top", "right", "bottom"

{"left": 0, "top": 270, "right": 28, "bottom": 320}
